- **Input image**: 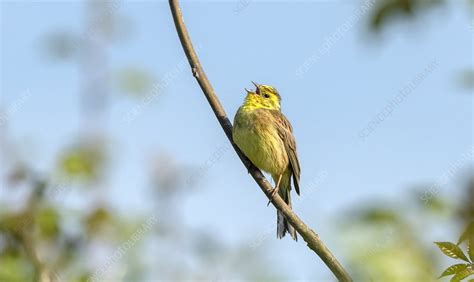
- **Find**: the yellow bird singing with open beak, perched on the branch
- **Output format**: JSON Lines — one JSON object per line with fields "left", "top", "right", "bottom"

{"left": 232, "top": 81, "right": 301, "bottom": 241}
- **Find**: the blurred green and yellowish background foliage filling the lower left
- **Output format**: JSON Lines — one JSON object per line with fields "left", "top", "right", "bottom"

{"left": 0, "top": 139, "right": 272, "bottom": 281}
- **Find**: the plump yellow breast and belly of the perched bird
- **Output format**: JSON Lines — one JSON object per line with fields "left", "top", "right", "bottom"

{"left": 232, "top": 107, "right": 289, "bottom": 175}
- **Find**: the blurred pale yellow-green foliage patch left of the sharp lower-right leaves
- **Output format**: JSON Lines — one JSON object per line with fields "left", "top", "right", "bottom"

{"left": 341, "top": 205, "right": 435, "bottom": 282}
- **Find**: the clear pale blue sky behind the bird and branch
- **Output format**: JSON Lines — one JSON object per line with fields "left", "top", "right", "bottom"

{"left": 0, "top": 0, "right": 474, "bottom": 278}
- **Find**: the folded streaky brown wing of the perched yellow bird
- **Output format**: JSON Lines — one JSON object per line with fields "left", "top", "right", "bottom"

{"left": 270, "top": 110, "right": 301, "bottom": 195}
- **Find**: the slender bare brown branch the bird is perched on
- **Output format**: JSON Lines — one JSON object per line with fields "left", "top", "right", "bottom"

{"left": 169, "top": 0, "right": 352, "bottom": 281}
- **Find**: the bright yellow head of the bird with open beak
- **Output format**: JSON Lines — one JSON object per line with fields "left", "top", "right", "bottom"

{"left": 244, "top": 81, "right": 281, "bottom": 111}
